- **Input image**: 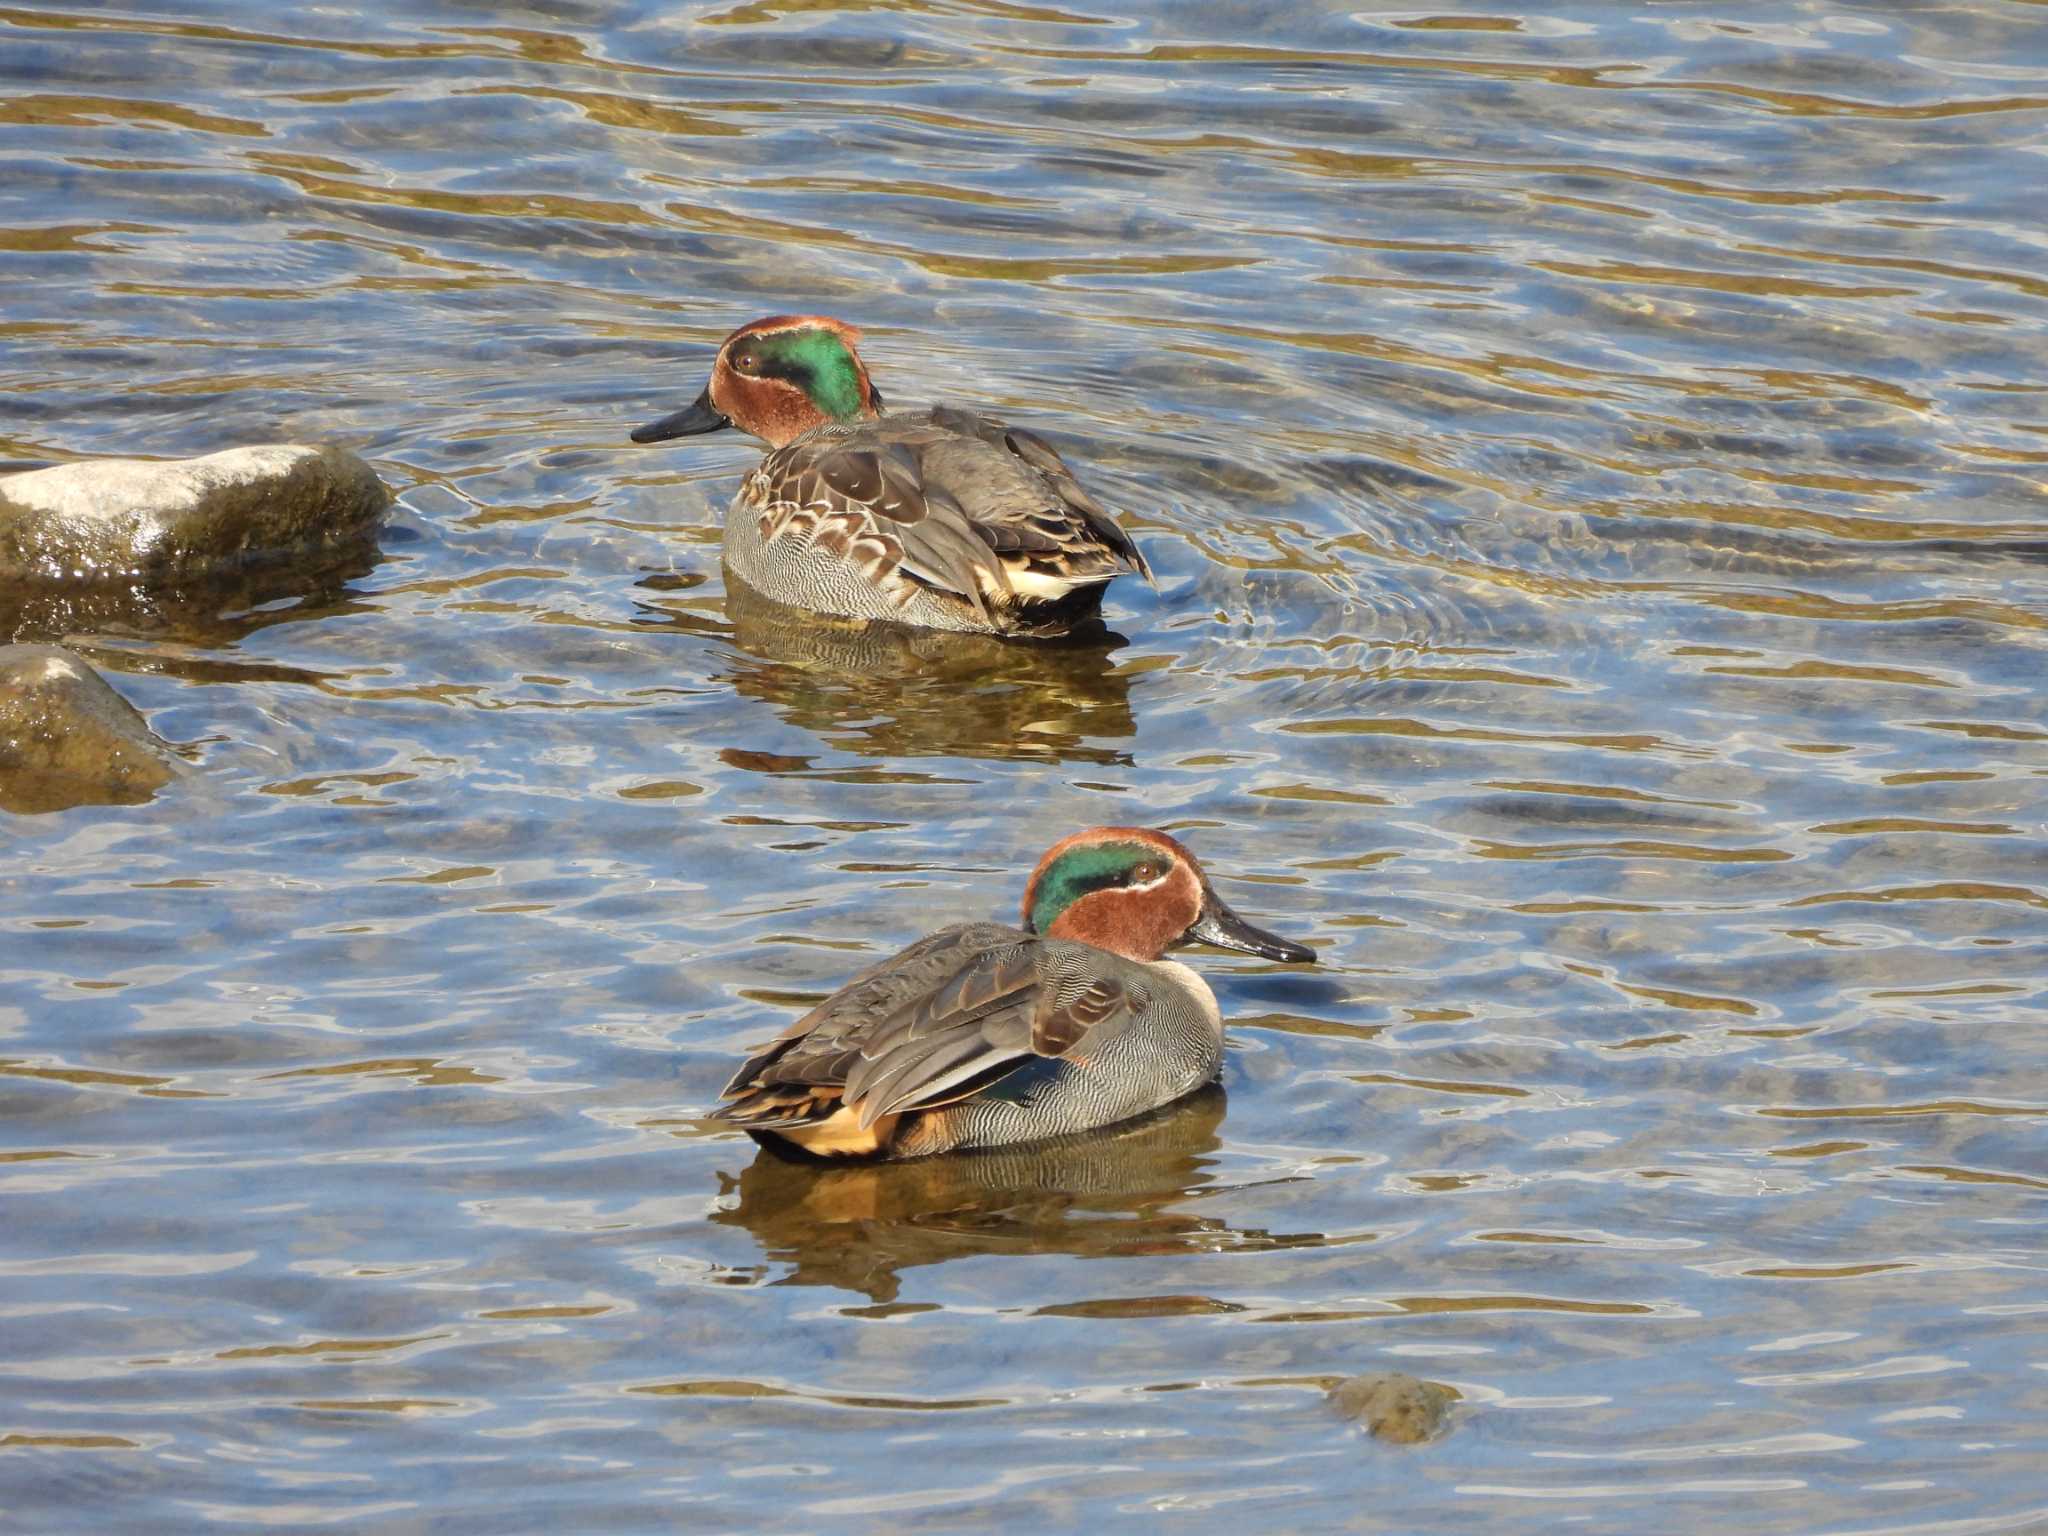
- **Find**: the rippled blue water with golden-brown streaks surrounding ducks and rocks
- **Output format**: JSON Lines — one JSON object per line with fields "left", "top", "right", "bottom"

{"left": 0, "top": 0, "right": 2048, "bottom": 1536}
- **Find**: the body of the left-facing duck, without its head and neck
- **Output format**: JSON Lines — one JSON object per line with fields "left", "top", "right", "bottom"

{"left": 725, "top": 406, "right": 1151, "bottom": 635}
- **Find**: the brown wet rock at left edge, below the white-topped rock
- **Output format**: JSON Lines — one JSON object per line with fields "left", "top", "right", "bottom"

{"left": 0, "top": 645, "right": 188, "bottom": 815}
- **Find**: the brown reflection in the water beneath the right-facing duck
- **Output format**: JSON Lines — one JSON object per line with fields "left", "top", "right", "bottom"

{"left": 713, "top": 1085, "right": 1223, "bottom": 1303}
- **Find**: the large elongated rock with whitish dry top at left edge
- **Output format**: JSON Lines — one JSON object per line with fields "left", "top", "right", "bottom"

{"left": 0, "top": 444, "right": 391, "bottom": 584}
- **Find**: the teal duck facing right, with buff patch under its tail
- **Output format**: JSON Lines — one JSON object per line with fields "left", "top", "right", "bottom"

{"left": 709, "top": 827, "right": 1315, "bottom": 1159}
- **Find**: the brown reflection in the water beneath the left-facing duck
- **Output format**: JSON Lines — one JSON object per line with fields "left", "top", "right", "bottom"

{"left": 704, "top": 575, "right": 1137, "bottom": 764}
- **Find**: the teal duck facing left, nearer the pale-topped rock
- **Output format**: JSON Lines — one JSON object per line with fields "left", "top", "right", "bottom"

{"left": 631, "top": 315, "right": 1153, "bottom": 637}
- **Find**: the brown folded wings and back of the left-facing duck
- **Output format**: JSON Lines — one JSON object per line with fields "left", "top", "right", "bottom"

{"left": 741, "top": 408, "right": 1151, "bottom": 621}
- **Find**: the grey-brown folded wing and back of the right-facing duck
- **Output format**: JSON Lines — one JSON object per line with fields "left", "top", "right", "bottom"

{"left": 717, "top": 924, "right": 1151, "bottom": 1128}
